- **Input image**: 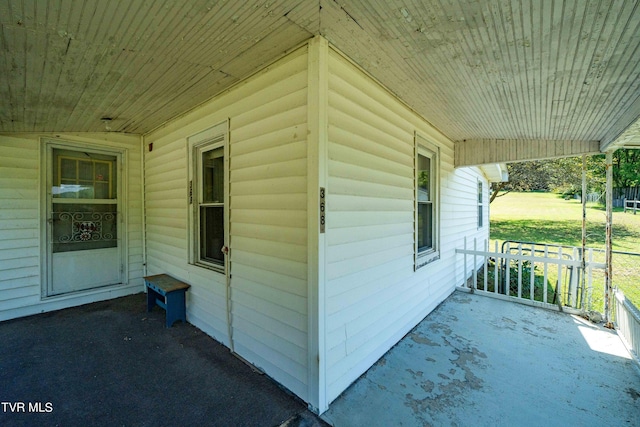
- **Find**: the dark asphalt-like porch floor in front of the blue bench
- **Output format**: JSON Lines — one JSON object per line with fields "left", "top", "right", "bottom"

{"left": 0, "top": 294, "right": 327, "bottom": 427}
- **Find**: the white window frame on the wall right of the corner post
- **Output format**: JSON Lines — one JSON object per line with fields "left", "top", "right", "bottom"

{"left": 414, "top": 133, "right": 440, "bottom": 270}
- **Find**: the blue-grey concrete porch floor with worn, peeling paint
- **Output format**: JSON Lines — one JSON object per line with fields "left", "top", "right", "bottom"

{"left": 322, "top": 291, "right": 640, "bottom": 427}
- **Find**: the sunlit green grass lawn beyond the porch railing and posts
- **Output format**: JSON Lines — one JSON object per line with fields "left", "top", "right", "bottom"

{"left": 490, "top": 193, "right": 640, "bottom": 311}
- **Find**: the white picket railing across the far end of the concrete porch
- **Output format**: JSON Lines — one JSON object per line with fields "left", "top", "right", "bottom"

{"left": 456, "top": 239, "right": 605, "bottom": 311}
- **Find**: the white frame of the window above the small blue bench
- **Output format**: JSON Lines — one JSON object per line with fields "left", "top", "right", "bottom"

{"left": 187, "top": 121, "right": 229, "bottom": 273}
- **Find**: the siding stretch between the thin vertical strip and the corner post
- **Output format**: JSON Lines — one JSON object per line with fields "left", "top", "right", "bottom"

{"left": 230, "top": 69, "right": 308, "bottom": 396}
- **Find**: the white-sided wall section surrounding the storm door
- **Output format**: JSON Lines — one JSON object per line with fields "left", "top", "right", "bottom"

{"left": 0, "top": 134, "right": 143, "bottom": 320}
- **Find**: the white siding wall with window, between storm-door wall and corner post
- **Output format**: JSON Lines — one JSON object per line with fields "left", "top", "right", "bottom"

{"left": 145, "top": 46, "right": 308, "bottom": 399}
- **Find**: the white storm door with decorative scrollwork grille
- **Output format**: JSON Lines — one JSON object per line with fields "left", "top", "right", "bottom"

{"left": 47, "top": 147, "right": 123, "bottom": 296}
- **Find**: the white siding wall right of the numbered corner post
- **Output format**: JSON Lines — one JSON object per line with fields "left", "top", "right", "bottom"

{"left": 324, "top": 50, "right": 488, "bottom": 403}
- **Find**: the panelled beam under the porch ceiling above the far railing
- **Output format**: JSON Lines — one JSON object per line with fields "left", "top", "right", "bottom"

{"left": 455, "top": 139, "right": 600, "bottom": 167}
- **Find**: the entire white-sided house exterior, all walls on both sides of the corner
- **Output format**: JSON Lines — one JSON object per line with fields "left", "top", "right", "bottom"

{"left": 0, "top": 38, "right": 488, "bottom": 412}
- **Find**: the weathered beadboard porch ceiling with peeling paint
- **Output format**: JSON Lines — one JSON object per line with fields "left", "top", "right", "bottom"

{"left": 0, "top": 0, "right": 640, "bottom": 148}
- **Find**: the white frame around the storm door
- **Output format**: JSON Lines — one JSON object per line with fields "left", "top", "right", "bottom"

{"left": 40, "top": 138, "right": 128, "bottom": 300}
